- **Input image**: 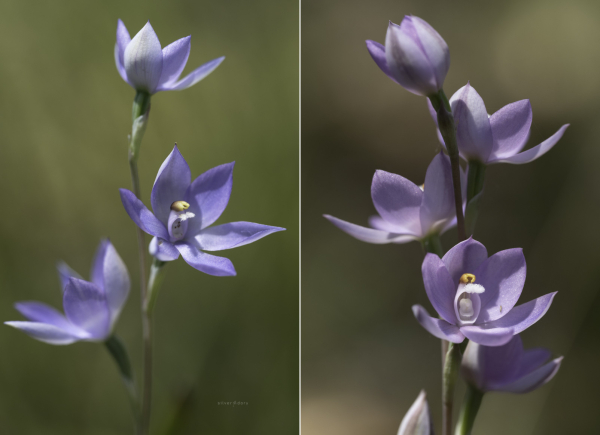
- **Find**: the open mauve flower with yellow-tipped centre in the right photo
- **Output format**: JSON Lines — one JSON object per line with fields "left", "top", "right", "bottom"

{"left": 413, "top": 238, "right": 556, "bottom": 346}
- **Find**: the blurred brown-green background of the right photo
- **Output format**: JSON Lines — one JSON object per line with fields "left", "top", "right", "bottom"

{"left": 301, "top": 0, "right": 600, "bottom": 435}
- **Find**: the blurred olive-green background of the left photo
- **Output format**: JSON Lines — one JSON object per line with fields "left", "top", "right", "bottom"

{"left": 0, "top": 0, "right": 299, "bottom": 435}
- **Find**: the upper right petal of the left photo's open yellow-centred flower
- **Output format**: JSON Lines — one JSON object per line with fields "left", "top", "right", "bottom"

{"left": 185, "top": 162, "right": 235, "bottom": 233}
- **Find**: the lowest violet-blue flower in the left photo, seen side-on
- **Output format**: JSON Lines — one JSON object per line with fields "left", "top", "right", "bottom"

{"left": 4, "top": 240, "right": 130, "bottom": 345}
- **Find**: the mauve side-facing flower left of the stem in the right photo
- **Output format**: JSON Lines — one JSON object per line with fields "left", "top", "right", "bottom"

{"left": 324, "top": 152, "right": 466, "bottom": 244}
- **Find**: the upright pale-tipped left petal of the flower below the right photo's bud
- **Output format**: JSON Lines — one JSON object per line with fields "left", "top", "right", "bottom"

{"left": 450, "top": 84, "right": 493, "bottom": 163}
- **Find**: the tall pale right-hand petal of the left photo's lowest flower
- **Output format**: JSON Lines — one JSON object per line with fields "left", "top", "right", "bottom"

{"left": 91, "top": 239, "right": 131, "bottom": 325}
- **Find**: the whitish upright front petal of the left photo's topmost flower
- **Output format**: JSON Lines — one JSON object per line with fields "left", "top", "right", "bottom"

{"left": 123, "top": 21, "right": 163, "bottom": 94}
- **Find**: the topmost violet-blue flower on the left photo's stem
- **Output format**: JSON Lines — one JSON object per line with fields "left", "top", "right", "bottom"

{"left": 115, "top": 20, "right": 225, "bottom": 94}
